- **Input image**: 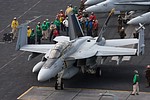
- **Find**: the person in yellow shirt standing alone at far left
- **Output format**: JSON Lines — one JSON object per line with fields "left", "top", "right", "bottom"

{"left": 11, "top": 17, "right": 19, "bottom": 40}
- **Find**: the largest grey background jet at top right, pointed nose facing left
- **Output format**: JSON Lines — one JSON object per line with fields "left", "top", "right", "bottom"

{"left": 84, "top": 0, "right": 150, "bottom": 13}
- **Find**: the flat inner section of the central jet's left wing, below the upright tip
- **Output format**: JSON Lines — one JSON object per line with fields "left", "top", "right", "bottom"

{"left": 20, "top": 44, "right": 55, "bottom": 54}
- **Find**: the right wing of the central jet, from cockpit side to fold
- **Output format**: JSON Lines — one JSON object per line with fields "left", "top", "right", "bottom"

{"left": 68, "top": 39, "right": 137, "bottom": 60}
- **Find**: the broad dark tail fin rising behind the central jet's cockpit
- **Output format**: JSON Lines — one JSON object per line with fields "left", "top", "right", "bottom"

{"left": 68, "top": 13, "right": 84, "bottom": 40}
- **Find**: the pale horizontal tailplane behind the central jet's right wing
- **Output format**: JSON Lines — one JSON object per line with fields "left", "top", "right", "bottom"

{"left": 105, "top": 39, "right": 139, "bottom": 46}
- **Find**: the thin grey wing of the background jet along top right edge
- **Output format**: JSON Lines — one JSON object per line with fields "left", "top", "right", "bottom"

{"left": 115, "top": 2, "right": 150, "bottom": 6}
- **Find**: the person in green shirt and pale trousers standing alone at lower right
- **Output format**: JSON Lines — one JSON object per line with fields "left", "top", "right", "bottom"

{"left": 131, "top": 70, "right": 139, "bottom": 95}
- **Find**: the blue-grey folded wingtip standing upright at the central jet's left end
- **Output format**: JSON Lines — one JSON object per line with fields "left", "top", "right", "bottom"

{"left": 16, "top": 23, "right": 28, "bottom": 50}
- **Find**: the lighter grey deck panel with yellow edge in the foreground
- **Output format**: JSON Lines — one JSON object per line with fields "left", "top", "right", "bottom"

{"left": 17, "top": 86, "right": 150, "bottom": 100}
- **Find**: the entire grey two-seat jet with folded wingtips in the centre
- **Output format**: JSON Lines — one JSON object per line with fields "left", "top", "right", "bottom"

{"left": 16, "top": 9, "right": 144, "bottom": 89}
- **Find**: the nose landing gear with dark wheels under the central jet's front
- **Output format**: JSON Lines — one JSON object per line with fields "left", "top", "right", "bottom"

{"left": 55, "top": 70, "right": 64, "bottom": 90}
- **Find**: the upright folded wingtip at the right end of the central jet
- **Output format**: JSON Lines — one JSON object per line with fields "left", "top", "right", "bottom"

{"left": 136, "top": 23, "right": 145, "bottom": 56}
